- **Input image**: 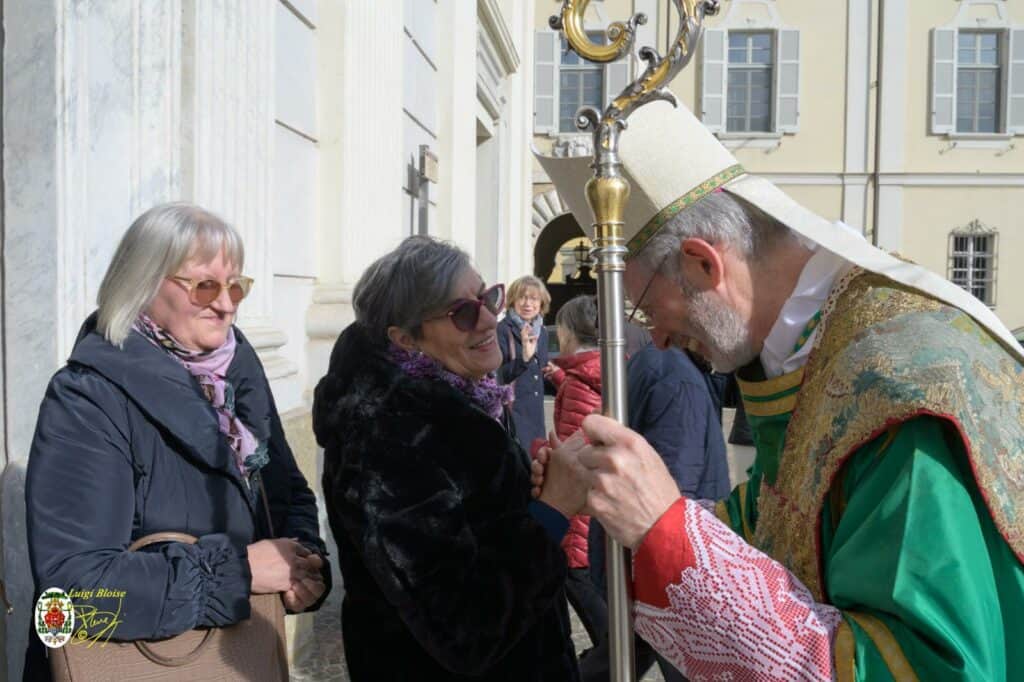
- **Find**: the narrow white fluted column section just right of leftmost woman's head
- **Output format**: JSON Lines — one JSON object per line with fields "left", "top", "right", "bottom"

{"left": 181, "top": 0, "right": 297, "bottom": 389}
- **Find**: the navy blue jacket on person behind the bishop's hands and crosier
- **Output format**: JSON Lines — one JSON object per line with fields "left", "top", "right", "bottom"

{"left": 589, "top": 345, "right": 729, "bottom": 585}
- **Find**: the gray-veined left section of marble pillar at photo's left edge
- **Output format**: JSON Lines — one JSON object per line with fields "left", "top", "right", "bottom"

{"left": 0, "top": 0, "right": 181, "bottom": 680}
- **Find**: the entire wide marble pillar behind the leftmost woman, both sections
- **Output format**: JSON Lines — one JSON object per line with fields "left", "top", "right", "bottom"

{"left": 0, "top": 0, "right": 301, "bottom": 680}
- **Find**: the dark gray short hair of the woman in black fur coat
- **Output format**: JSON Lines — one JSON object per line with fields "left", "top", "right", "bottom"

{"left": 352, "top": 236, "right": 472, "bottom": 343}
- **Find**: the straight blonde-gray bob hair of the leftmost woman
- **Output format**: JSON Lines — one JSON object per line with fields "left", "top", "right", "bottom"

{"left": 96, "top": 202, "right": 246, "bottom": 347}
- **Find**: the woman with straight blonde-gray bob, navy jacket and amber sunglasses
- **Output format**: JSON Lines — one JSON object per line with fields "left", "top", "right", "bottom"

{"left": 26, "top": 204, "right": 330, "bottom": 679}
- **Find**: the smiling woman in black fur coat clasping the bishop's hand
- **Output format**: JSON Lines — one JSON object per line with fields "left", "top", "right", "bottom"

{"left": 313, "top": 237, "right": 582, "bottom": 682}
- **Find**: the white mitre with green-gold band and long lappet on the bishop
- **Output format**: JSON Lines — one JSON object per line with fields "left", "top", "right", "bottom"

{"left": 535, "top": 101, "right": 1024, "bottom": 361}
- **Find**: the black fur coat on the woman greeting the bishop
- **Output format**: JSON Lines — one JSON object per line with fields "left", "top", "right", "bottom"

{"left": 313, "top": 325, "right": 579, "bottom": 682}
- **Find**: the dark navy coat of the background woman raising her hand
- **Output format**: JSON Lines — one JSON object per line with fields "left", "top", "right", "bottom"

{"left": 498, "top": 317, "right": 548, "bottom": 453}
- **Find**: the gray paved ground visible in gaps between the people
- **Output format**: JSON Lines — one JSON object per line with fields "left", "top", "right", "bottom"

{"left": 292, "top": 406, "right": 754, "bottom": 682}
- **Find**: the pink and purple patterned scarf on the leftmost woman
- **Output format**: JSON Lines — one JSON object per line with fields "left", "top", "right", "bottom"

{"left": 133, "top": 313, "right": 266, "bottom": 477}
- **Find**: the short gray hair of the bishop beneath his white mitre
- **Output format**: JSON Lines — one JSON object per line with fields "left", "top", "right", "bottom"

{"left": 631, "top": 189, "right": 813, "bottom": 273}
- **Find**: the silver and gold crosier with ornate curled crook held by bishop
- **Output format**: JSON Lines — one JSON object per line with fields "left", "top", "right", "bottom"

{"left": 549, "top": 0, "right": 719, "bottom": 682}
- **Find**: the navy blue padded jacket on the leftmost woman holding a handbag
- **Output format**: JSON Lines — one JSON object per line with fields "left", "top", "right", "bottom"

{"left": 26, "top": 316, "right": 330, "bottom": 667}
